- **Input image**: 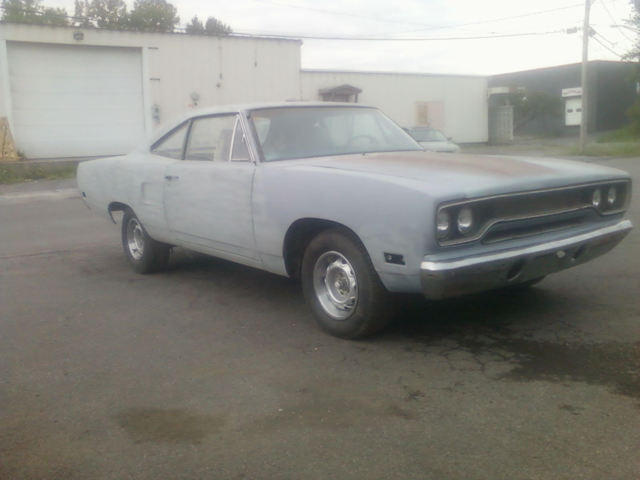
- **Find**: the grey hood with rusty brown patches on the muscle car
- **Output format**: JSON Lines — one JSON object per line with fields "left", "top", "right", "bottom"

{"left": 277, "top": 151, "right": 629, "bottom": 199}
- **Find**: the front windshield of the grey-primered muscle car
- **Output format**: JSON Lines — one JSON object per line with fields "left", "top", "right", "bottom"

{"left": 250, "top": 106, "right": 421, "bottom": 162}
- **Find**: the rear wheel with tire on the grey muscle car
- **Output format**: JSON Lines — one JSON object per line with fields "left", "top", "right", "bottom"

{"left": 122, "top": 209, "right": 171, "bottom": 273}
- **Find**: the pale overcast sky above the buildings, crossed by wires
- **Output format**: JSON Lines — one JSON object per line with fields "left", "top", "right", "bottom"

{"left": 43, "top": 0, "right": 637, "bottom": 75}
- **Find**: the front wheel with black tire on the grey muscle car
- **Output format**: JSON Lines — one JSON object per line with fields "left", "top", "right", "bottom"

{"left": 301, "top": 228, "right": 393, "bottom": 339}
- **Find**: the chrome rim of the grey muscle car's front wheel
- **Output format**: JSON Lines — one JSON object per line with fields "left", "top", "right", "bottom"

{"left": 313, "top": 251, "right": 358, "bottom": 320}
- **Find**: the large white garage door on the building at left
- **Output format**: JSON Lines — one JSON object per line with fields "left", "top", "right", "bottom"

{"left": 7, "top": 42, "right": 144, "bottom": 158}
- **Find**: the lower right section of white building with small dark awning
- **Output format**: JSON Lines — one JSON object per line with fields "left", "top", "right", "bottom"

{"left": 301, "top": 70, "right": 488, "bottom": 143}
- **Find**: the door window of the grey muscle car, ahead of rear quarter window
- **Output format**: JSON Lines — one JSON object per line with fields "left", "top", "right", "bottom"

{"left": 184, "top": 115, "right": 236, "bottom": 162}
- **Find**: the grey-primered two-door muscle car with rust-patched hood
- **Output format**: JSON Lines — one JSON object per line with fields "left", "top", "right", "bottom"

{"left": 78, "top": 103, "right": 632, "bottom": 338}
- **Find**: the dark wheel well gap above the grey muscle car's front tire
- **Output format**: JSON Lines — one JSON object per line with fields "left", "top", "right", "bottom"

{"left": 282, "top": 218, "right": 362, "bottom": 278}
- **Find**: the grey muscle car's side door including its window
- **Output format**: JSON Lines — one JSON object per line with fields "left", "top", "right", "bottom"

{"left": 164, "top": 114, "right": 258, "bottom": 260}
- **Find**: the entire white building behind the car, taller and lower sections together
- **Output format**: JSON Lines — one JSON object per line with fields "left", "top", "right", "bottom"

{"left": 0, "top": 24, "right": 487, "bottom": 158}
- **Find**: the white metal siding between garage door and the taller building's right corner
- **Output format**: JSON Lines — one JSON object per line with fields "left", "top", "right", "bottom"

{"left": 149, "top": 35, "right": 300, "bottom": 123}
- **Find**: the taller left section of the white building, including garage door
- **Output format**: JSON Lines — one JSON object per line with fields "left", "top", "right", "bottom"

{"left": 0, "top": 24, "right": 300, "bottom": 158}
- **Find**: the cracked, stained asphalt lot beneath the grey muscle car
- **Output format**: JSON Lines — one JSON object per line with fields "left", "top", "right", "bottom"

{"left": 0, "top": 158, "right": 640, "bottom": 480}
